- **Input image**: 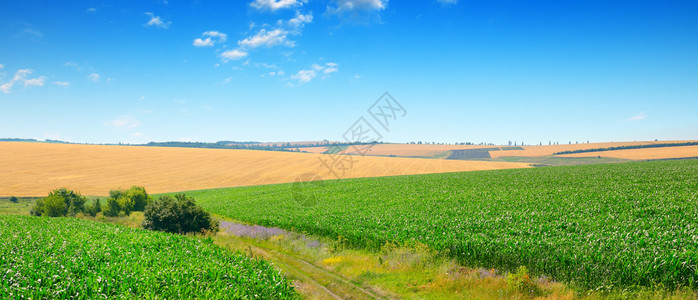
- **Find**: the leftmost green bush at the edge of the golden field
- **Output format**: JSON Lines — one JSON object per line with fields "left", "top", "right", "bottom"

{"left": 30, "top": 188, "right": 87, "bottom": 217}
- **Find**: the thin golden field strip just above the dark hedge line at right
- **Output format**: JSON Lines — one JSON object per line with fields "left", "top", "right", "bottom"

{"left": 490, "top": 141, "right": 692, "bottom": 158}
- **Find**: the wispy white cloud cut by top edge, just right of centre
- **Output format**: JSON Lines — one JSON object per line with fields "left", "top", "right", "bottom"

{"left": 327, "top": 0, "right": 388, "bottom": 23}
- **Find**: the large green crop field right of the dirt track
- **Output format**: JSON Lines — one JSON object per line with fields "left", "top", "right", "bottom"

{"left": 182, "top": 160, "right": 698, "bottom": 289}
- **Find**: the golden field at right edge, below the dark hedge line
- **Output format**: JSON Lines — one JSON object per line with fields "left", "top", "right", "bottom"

{"left": 557, "top": 146, "right": 698, "bottom": 160}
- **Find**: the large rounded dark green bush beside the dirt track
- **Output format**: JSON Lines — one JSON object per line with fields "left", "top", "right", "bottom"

{"left": 143, "top": 194, "right": 218, "bottom": 234}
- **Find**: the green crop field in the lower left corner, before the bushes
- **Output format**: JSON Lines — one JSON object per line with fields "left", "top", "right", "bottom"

{"left": 0, "top": 215, "right": 297, "bottom": 299}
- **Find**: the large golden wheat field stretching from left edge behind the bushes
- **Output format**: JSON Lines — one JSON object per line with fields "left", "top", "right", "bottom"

{"left": 0, "top": 142, "right": 529, "bottom": 196}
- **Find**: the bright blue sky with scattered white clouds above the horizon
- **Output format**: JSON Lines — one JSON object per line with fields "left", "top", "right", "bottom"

{"left": 0, "top": 0, "right": 698, "bottom": 144}
